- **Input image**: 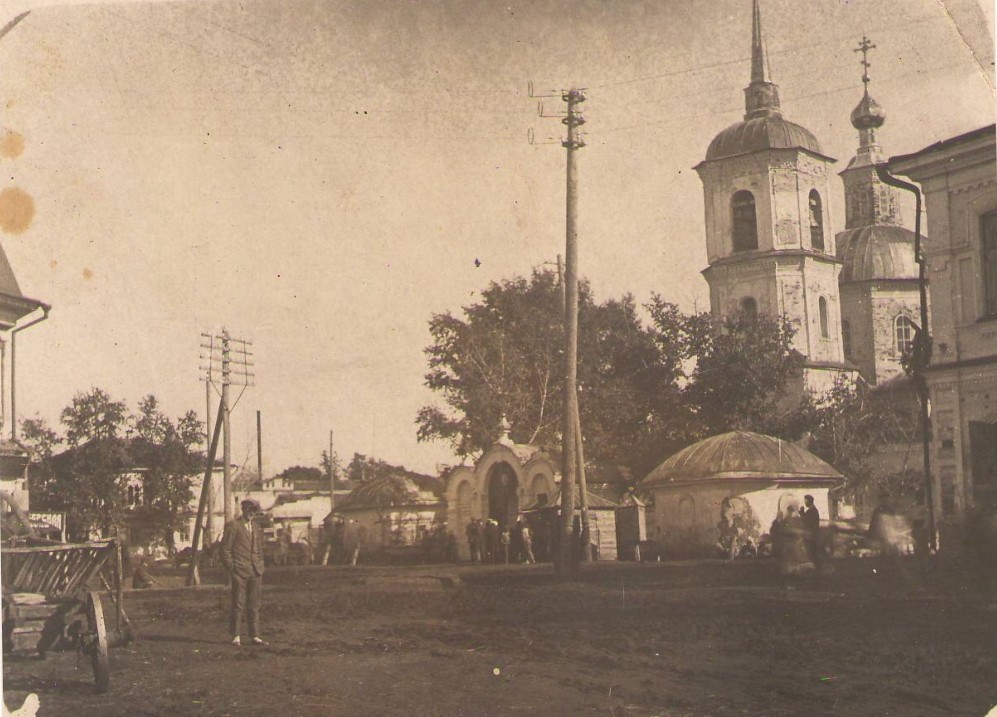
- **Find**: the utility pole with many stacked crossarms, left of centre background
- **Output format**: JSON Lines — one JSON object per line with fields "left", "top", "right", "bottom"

{"left": 201, "top": 329, "right": 254, "bottom": 523}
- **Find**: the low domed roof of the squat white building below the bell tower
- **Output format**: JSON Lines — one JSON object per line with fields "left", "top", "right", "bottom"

{"left": 640, "top": 431, "right": 842, "bottom": 488}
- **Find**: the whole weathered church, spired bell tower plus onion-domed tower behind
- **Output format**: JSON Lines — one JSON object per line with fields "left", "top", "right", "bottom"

{"left": 696, "top": 0, "right": 920, "bottom": 394}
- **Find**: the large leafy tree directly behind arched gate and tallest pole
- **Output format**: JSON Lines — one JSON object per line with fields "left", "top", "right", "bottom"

{"left": 416, "top": 270, "right": 677, "bottom": 476}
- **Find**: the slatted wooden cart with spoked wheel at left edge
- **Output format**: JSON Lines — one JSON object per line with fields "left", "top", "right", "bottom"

{"left": 0, "top": 540, "right": 132, "bottom": 692}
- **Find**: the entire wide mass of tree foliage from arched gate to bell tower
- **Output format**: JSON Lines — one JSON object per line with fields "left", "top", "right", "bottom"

{"left": 416, "top": 270, "right": 803, "bottom": 477}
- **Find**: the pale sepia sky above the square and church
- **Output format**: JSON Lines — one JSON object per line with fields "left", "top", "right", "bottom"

{"left": 0, "top": 0, "right": 995, "bottom": 475}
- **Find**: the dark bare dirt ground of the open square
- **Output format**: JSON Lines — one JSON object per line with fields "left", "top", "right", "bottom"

{"left": 3, "top": 560, "right": 997, "bottom": 717}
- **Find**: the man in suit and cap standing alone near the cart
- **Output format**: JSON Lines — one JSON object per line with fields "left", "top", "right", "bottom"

{"left": 222, "top": 499, "right": 266, "bottom": 645}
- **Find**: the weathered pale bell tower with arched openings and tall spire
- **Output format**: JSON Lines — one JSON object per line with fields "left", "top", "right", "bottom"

{"left": 696, "top": 0, "right": 851, "bottom": 392}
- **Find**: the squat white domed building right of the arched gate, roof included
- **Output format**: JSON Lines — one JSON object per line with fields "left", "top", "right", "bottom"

{"left": 639, "top": 431, "right": 844, "bottom": 557}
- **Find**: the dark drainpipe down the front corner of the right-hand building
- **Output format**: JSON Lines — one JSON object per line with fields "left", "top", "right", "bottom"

{"left": 876, "top": 162, "right": 938, "bottom": 552}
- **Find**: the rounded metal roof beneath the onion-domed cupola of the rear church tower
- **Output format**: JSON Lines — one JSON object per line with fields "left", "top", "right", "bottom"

{"left": 837, "top": 225, "right": 918, "bottom": 282}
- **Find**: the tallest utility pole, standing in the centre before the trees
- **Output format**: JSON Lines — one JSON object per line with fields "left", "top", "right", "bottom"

{"left": 556, "top": 89, "right": 585, "bottom": 576}
